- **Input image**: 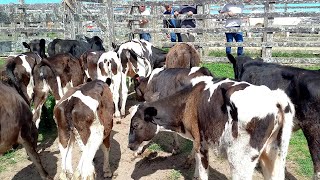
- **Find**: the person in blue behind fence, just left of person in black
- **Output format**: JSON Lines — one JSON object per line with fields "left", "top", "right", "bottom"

{"left": 163, "top": 4, "right": 182, "bottom": 42}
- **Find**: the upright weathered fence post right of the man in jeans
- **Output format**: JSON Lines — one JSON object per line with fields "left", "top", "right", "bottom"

{"left": 261, "top": 2, "right": 275, "bottom": 62}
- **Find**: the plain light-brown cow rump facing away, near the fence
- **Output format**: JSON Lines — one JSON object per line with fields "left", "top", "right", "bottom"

{"left": 165, "top": 43, "right": 200, "bottom": 68}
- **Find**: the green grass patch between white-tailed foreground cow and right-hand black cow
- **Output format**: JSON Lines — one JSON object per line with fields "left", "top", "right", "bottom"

{"left": 288, "top": 130, "right": 313, "bottom": 179}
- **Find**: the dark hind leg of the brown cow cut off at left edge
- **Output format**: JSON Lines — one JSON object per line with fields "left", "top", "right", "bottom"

{"left": 18, "top": 135, "right": 52, "bottom": 179}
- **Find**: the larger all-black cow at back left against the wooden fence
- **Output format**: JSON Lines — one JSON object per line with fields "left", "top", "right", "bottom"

{"left": 48, "top": 36, "right": 105, "bottom": 59}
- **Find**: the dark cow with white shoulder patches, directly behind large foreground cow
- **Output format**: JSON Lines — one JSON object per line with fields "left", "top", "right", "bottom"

{"left": 134, "top": 67, "right": 212, "bottom": 156}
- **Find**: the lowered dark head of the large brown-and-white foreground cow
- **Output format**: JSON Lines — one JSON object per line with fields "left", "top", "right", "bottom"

{"left": 128, "top": 105, "right": 158, "bottom": 153}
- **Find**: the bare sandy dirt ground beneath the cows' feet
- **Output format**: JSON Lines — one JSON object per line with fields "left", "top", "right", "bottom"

{"left": 0, "top": 100, "right": 303, "bottom": 180}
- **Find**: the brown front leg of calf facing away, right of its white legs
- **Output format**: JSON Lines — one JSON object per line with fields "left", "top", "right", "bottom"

{"left": 101, "top": 134, "right": 112, "bottom": 178}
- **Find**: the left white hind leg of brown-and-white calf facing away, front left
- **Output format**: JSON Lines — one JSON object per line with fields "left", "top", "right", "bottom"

{"left": 59, "top": 134, "right": 75, "bottom": 180}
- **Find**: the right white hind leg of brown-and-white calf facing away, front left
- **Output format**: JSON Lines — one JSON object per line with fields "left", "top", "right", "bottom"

{"left": 74, "top": 124, "right": 104, "bottom": 180}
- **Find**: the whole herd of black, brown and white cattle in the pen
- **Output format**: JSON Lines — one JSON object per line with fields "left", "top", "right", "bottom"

{"left": 0, "top": 36, "right": 320, "bottom": 180}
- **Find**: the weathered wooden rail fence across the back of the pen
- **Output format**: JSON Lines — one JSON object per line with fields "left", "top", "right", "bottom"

{"left": 0, "top": 0, "right": 320, "bottom": 64}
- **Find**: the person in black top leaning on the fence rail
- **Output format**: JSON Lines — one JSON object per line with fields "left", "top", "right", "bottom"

{"left": 174, "top": 5, "right": 197, "bottom": 42}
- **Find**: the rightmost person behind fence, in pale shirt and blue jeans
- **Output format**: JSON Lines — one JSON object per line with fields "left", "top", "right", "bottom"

{"left": 219, "top": 0, "right": 251, "bottom": 56}
